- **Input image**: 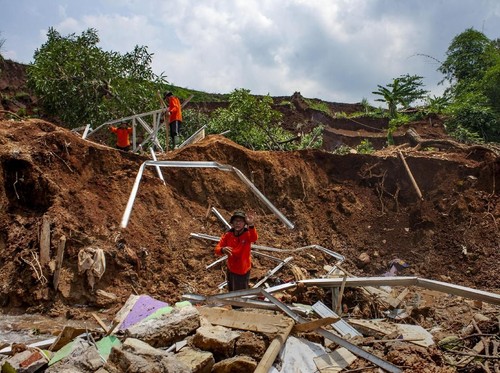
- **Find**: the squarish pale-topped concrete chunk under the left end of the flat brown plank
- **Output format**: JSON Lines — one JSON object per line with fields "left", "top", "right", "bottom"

{"left": 193, "top": 325, "right": 240, "bottom": 358}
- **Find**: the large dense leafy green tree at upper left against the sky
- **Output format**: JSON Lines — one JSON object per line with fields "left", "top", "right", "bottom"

{"left": 28, "top": 28, "right": 165, "bottom": 127}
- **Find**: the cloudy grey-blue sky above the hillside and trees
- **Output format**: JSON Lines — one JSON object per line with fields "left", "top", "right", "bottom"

{"left": 0, "top": 0, "right": 500, "bottom": 103}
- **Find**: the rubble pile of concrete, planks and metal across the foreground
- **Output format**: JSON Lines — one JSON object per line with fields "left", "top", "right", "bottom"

{"left": 0, "top": 268, "right": 500, "bottom": 373}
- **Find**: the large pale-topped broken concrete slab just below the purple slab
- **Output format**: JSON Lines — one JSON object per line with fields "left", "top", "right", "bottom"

{"left": 125, "top": 307, "right": 200, "bottom": 347}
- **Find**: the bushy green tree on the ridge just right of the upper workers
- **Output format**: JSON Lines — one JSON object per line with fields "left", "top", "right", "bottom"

{"left": 207, "top": 89, "right": 292, "bottom": 150}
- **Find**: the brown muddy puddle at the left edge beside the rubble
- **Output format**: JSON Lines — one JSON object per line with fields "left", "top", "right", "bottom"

{"left": 0, "top": 314, "right": 97, "bottom": 344}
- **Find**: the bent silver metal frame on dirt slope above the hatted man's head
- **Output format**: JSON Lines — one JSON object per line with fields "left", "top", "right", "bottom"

{"left": 120, "top": 161, "right": 295, "bottom": 229}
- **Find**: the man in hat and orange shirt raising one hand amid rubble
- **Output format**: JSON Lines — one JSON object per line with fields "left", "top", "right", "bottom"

{"left": 215, "top": 211, "right": 258, "bottom": 291}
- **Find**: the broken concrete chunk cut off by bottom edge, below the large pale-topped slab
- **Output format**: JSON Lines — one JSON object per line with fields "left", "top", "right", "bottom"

{"left": 104, "top": 347, "right": 191, "bottom": 373}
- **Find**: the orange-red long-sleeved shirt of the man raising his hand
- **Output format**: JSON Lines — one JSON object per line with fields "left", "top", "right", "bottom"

{"left": 215, "top": 227, "right": 259, "bottom": 275}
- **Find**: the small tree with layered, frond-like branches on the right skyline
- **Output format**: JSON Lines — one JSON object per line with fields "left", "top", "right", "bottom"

{"left": 372, "top": 74, "right": 428, "bottom": 118}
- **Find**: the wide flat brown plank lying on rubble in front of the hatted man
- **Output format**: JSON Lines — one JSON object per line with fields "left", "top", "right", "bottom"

{"left": 199, "top": 307, "right": 290, "bottom": 334}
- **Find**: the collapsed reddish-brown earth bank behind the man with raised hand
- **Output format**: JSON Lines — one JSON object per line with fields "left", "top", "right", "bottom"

{"left": 0, "top": 120, "right": 500, "bottom": 314}
